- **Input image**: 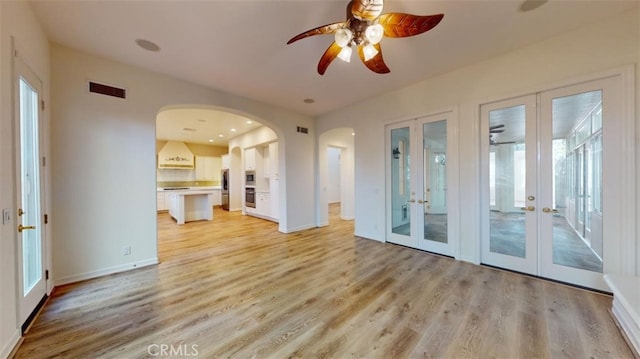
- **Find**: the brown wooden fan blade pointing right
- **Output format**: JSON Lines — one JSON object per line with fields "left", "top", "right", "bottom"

{"left": 379, "top": 12, "right": 444, "bottom": 37}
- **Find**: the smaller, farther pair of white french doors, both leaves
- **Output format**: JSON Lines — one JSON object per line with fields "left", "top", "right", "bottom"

{"left": 386, "top": 112, "right": 458, "bottom": 256}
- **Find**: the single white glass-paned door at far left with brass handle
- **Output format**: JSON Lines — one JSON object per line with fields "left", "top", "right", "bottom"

{"left": 15, "top": 57, "right": 47, "bottom": 323}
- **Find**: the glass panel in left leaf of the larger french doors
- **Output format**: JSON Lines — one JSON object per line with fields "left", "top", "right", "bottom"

{"left": 488, "top": 105, "right": 526, "bottom": 258}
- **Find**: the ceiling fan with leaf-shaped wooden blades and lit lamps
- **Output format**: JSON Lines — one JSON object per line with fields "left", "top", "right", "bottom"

{"left": 287, "top": 0, "right": 444, "bottom": 75}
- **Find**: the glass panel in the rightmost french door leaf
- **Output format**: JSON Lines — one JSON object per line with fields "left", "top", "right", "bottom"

{"left": 550, "top": 90, "right": 603, "bottom": 273}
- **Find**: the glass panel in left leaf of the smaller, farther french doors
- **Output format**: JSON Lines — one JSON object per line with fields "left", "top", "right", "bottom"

{"left": 390, "top": 127, "right": 411, "bottom": 236}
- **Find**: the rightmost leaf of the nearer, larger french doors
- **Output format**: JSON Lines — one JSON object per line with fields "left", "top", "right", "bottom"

{"left": 541, "top": 80, "right": 616, "bottom": 289}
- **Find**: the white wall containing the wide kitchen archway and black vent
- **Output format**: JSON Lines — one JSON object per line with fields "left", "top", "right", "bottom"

{"left": 51, "top": 44, "right": 315, "bottom": 284}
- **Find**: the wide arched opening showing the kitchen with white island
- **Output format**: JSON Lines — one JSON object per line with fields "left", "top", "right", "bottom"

{"left": 156, "top": 105, "right": 282, "bottom": 260}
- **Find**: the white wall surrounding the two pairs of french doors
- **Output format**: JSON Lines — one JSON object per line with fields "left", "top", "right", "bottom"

{"left": 317, "top": 9, "right": 640, "bottom": 266}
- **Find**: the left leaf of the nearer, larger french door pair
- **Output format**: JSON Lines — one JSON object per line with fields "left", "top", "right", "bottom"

{"left": 482, "top": 95, "right": 537, "bottom": 273}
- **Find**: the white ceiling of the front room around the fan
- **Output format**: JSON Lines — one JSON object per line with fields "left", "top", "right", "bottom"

{"left": 31, "top": 0, "right": 638, "bottom": 131}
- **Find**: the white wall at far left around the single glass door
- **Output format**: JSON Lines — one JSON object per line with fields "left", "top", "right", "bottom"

{"left": 0, "top": 1, "right": 53, "bottom": 358}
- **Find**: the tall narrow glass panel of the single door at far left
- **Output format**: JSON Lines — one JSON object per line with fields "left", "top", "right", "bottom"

{"left": 19, "top": 78, "right": 42, "bottom": 295}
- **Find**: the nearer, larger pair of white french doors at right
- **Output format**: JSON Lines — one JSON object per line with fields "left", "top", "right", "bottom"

{"left": 481, "top": 78, "right": 623, "bottom": 290}
